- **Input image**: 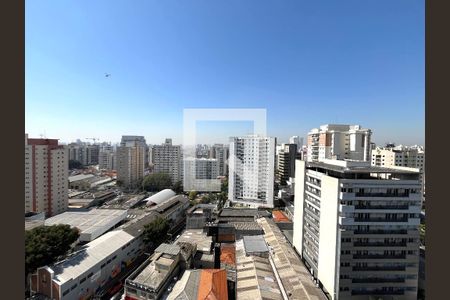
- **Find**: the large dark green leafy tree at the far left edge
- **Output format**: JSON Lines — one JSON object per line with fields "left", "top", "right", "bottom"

{"left": 25, "top": 225, "right": 80, "bottom": 274}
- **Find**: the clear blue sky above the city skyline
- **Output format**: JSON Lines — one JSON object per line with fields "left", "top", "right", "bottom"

{"left": 25, "top": 0, "right": 425, "bottom": 144}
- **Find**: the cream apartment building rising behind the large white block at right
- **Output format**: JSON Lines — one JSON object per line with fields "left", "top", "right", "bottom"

{"left": 307, "top": 124, "right": 372, "bottom": 161}
